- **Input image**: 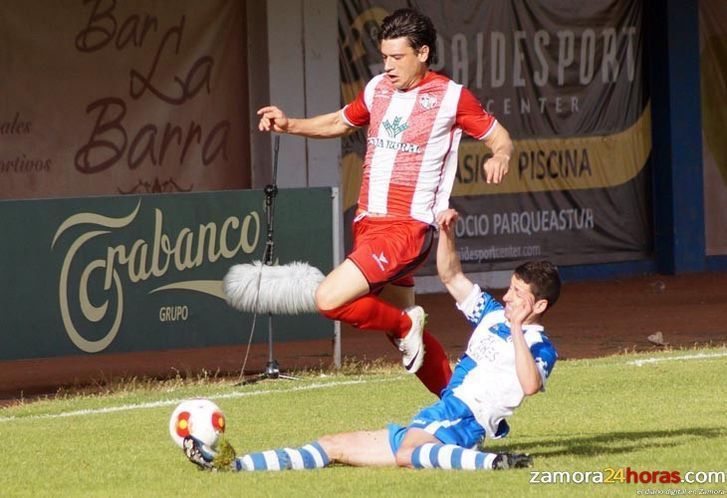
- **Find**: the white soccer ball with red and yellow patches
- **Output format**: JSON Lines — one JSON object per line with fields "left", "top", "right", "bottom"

{"left": 169, "top": 398, "right": 225, "bottom": 450}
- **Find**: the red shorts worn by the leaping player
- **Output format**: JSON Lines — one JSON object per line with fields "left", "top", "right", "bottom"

{"left": 348, "top": 216, "right": 434, "bottom": 291}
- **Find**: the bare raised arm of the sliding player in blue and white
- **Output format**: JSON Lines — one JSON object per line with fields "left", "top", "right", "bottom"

{"left": 437, "top": 209, "right": 474, "bottom": 303}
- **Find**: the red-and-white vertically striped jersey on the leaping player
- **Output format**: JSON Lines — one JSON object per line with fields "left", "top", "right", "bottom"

{"left": 341, "top": 71, "right": 497, "bottom": 224}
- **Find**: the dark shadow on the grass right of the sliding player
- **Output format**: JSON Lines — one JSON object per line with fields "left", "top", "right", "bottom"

{"left": 497, "top": 427, "right": 727, "bottom": 458}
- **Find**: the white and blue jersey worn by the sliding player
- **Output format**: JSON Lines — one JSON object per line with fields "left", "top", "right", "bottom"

{"left": 443, "top": 285, "right": 558, "bottom": 437}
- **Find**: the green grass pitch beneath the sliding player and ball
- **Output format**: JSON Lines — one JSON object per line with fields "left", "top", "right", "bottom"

{"left": 0, "top": 349, "right": 727, "bottom": 497}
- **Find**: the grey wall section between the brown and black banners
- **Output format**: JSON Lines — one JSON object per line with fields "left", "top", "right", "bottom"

{"left": 247, "top": 0, "right": 341, "bottom": 188}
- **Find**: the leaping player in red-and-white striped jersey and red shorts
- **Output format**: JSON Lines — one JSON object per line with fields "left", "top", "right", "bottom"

{"left": 258, "top": 9, "right": 512, "bottom": 395}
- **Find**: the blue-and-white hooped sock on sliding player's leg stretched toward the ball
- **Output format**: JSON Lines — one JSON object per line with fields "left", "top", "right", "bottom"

{"left": 235, "top": 442, "right": 330, "bottom": 471}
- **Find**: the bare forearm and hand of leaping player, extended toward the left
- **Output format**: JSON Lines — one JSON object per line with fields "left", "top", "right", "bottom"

{"left": 257, "top": 105, "right": 353, "bottom": 138}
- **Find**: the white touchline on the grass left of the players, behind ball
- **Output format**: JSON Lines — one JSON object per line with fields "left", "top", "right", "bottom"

{"left": 0, "top": 376, "right": 404, "bottom": 423}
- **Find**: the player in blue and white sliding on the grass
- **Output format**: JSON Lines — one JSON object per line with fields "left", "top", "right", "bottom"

{"left": 184, "top": 209, "right": 560, "bottom": 471}
